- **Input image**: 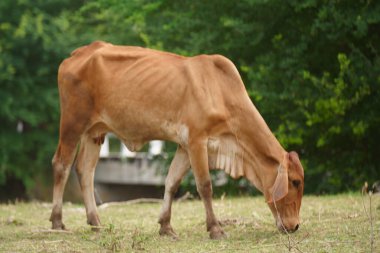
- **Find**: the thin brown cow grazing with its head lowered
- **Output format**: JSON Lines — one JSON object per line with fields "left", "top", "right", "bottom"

{"left": 50, "top": 42, "right": 304, "bottom": 238}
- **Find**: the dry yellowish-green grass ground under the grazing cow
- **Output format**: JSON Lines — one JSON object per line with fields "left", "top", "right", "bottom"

{"left": 0, "top": 194, "right": 380, "bottom": 252}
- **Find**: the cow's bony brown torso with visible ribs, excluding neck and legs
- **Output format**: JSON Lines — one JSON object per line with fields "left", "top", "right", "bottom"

{"left": 59, "top": 42, "right": 246, "bottom": 147}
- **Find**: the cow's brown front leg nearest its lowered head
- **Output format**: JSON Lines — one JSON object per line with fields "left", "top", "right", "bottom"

{"left": 189, "top": 138, "right": 226, "bottom": 239}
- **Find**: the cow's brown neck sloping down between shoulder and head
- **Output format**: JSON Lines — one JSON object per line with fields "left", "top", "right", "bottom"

{"left": 235, "top": 104, "right": 286, "bottom": 196}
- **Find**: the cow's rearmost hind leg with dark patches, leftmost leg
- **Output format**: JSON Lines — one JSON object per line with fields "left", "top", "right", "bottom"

{"left": 50, "top": 138, "right": 79, "bottom": 229}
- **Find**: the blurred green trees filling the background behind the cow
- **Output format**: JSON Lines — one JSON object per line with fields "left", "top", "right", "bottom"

{"left": 0, "top": 0, "right": 380, "bottom": 193}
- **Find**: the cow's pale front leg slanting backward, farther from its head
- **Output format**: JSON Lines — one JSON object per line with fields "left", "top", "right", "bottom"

{"left": 158, "top": 146, "right": 190, "bottom": 238}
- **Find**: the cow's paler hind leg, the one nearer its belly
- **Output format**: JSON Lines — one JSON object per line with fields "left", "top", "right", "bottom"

{"left": 76, "top": 134, "right": 104, "bottom": 231}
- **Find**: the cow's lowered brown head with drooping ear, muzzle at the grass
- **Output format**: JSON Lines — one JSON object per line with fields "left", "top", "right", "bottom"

{"left": 268, "top": 152, "right": 304, "bottom": 232}
